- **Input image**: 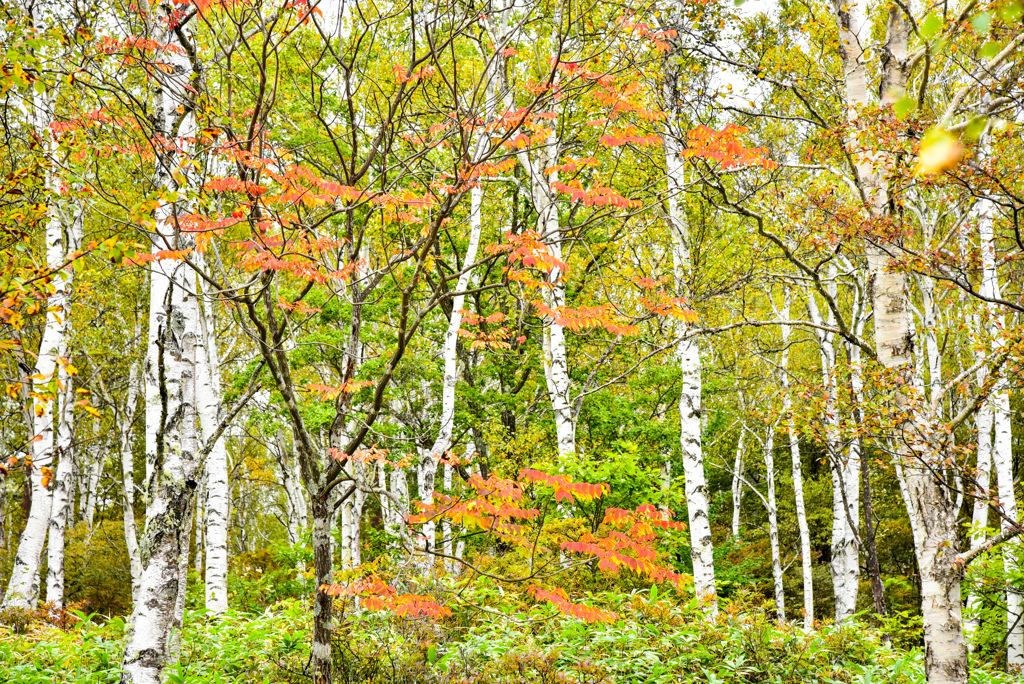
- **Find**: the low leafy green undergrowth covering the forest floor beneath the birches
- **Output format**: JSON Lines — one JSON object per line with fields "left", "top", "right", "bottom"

{"left": 0, "top": 589, "right": 1014, "bottom": 684}
